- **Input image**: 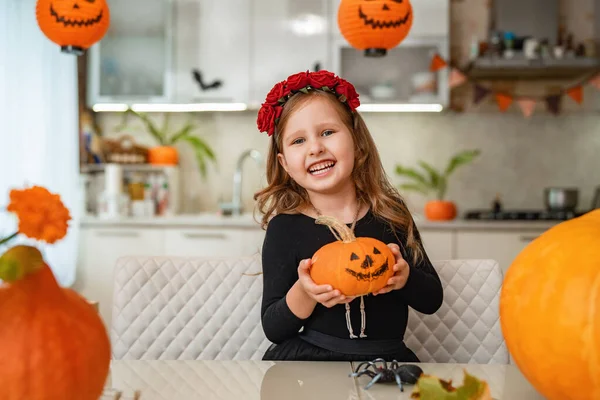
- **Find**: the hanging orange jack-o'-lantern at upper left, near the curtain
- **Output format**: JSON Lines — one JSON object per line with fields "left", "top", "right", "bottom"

{"left": 36, "top": 0, "right": 110, "bottom": 55}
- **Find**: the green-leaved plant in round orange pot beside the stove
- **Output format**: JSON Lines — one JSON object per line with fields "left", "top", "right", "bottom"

{"left": 396, "top": 150, "right": 480, "bottom": 221}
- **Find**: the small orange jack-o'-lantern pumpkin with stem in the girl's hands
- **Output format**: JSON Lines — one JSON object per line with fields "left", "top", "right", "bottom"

{"left": 310, "top": 216, "right": 396, "bottom": 296}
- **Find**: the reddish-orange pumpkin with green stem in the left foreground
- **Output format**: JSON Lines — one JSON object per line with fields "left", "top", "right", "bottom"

{"left": 0, "top": 246, "right": 110, "bottom": 400}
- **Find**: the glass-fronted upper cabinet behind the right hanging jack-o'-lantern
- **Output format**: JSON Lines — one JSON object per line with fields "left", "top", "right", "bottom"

{"left": 330, "top": 0, "right": 450, "bottom": 110}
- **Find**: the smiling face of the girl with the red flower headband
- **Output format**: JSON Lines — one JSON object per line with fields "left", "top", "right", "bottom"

{"left": 277, "top": 96, "right": 354, "bottom": 198}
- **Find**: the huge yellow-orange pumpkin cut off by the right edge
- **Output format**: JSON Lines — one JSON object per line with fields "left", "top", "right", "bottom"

{"left": 500, "top": 210, "right": 600, "bottom": 400}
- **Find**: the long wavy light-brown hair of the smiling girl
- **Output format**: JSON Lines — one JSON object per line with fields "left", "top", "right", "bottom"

{"left": 254, "top": 90, "right": 424, "bottom": 263}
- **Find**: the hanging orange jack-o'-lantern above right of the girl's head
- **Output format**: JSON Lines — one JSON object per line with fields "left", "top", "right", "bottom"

{"left": 338, "top": 0, "right": 413, "bottom": 57}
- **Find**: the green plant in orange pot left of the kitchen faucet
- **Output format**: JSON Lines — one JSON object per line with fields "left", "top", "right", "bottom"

{"left": 117, "top": 108, "right": 216, "bottom": 177}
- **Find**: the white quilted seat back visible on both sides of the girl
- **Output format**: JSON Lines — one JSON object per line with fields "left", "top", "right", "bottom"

{"left": 111, "top": 254, "right": 508, "bottom": 363}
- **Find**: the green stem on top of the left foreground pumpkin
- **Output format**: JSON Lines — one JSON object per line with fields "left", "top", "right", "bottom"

{"left": 0, "top": 245, "right": 44, "bottom": 282}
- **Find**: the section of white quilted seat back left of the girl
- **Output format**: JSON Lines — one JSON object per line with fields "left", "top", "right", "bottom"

{"left": 111, "top": 255, "right": 271, "bottom": 360}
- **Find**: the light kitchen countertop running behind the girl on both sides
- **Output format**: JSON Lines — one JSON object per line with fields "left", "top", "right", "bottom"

{"left": 81, "top": 213, "right": 561, "bottom": 231}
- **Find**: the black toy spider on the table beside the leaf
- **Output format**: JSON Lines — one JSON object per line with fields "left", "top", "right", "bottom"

{"left": 350, "top": 358, "right": 423, "bottom": 392}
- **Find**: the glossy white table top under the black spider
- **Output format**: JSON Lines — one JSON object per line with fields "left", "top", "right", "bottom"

{"left": 101, "top": 360, "right": 543, "bottom": 400}
